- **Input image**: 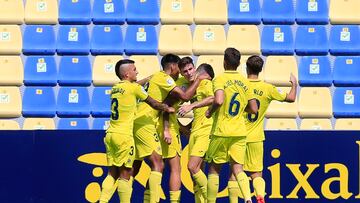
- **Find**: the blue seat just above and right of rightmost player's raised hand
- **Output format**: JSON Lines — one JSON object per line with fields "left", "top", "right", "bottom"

{"left": 299, "top": 56, "right": 333, "bottom": 87}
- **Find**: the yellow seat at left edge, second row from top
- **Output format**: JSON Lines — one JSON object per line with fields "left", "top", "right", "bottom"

{"left": 0, "top": 25, "right": 22, "bottom": 55}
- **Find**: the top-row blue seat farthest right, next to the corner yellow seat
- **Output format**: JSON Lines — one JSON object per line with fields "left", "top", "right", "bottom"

{"left": 296, "top": 0, "right": 329, "bottom": 25}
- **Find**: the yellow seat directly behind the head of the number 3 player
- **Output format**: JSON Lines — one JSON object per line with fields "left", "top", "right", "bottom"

{"left": 93, "top": 55, "right": 123, "bottom": 86}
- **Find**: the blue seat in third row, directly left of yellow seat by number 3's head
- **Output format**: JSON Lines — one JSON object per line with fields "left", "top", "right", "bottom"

{"left": 58, "top": 56, "right": 92, "bottom": 86}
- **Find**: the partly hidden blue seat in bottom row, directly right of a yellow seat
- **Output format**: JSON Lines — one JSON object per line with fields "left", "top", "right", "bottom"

{"left": 57, "top": 118, "right": 89, "bottom": 130}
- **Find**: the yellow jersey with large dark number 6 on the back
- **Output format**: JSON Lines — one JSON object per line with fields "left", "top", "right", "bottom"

{"left": 212, "top": 71, "right": 254, "bottom": 137}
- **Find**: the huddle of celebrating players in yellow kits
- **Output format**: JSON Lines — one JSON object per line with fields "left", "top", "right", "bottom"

{"left": 100, "top": 48, "right": 297, "bottom": 203}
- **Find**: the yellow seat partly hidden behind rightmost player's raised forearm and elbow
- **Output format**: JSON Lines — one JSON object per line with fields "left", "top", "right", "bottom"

{"left": 266, "top": 87, "right": 298, "bottom": 118}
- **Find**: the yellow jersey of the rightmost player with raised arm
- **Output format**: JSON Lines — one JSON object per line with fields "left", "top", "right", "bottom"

{"left": 244, "top": 80, "right": 286, "bottom": 142}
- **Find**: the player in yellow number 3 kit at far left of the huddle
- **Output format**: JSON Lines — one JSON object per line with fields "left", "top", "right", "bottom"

{"left": 100, "top": 59, "right": 175, "bottom": 202}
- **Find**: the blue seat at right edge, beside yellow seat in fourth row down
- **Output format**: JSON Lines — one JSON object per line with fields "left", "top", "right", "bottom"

{"left": 333, "top": 87, "right": 360, "bottom": 118}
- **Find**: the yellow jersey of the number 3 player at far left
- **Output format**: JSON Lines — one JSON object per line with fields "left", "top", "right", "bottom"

{"left": 107, "top": 80, "right": 148, "bottom": 136}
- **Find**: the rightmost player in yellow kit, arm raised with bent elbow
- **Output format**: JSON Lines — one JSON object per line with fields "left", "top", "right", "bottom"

{"left": 228, "top": 56, "right": 297, "bottom": 203}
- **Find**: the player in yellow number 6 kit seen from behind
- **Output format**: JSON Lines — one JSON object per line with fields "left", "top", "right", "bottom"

{"left": 206, "top": 48, "right": 258, "bottom": 203}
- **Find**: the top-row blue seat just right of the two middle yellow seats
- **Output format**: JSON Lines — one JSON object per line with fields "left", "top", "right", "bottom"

{"left": 228, "top": 0, "right": 261, "bottom": 25}
